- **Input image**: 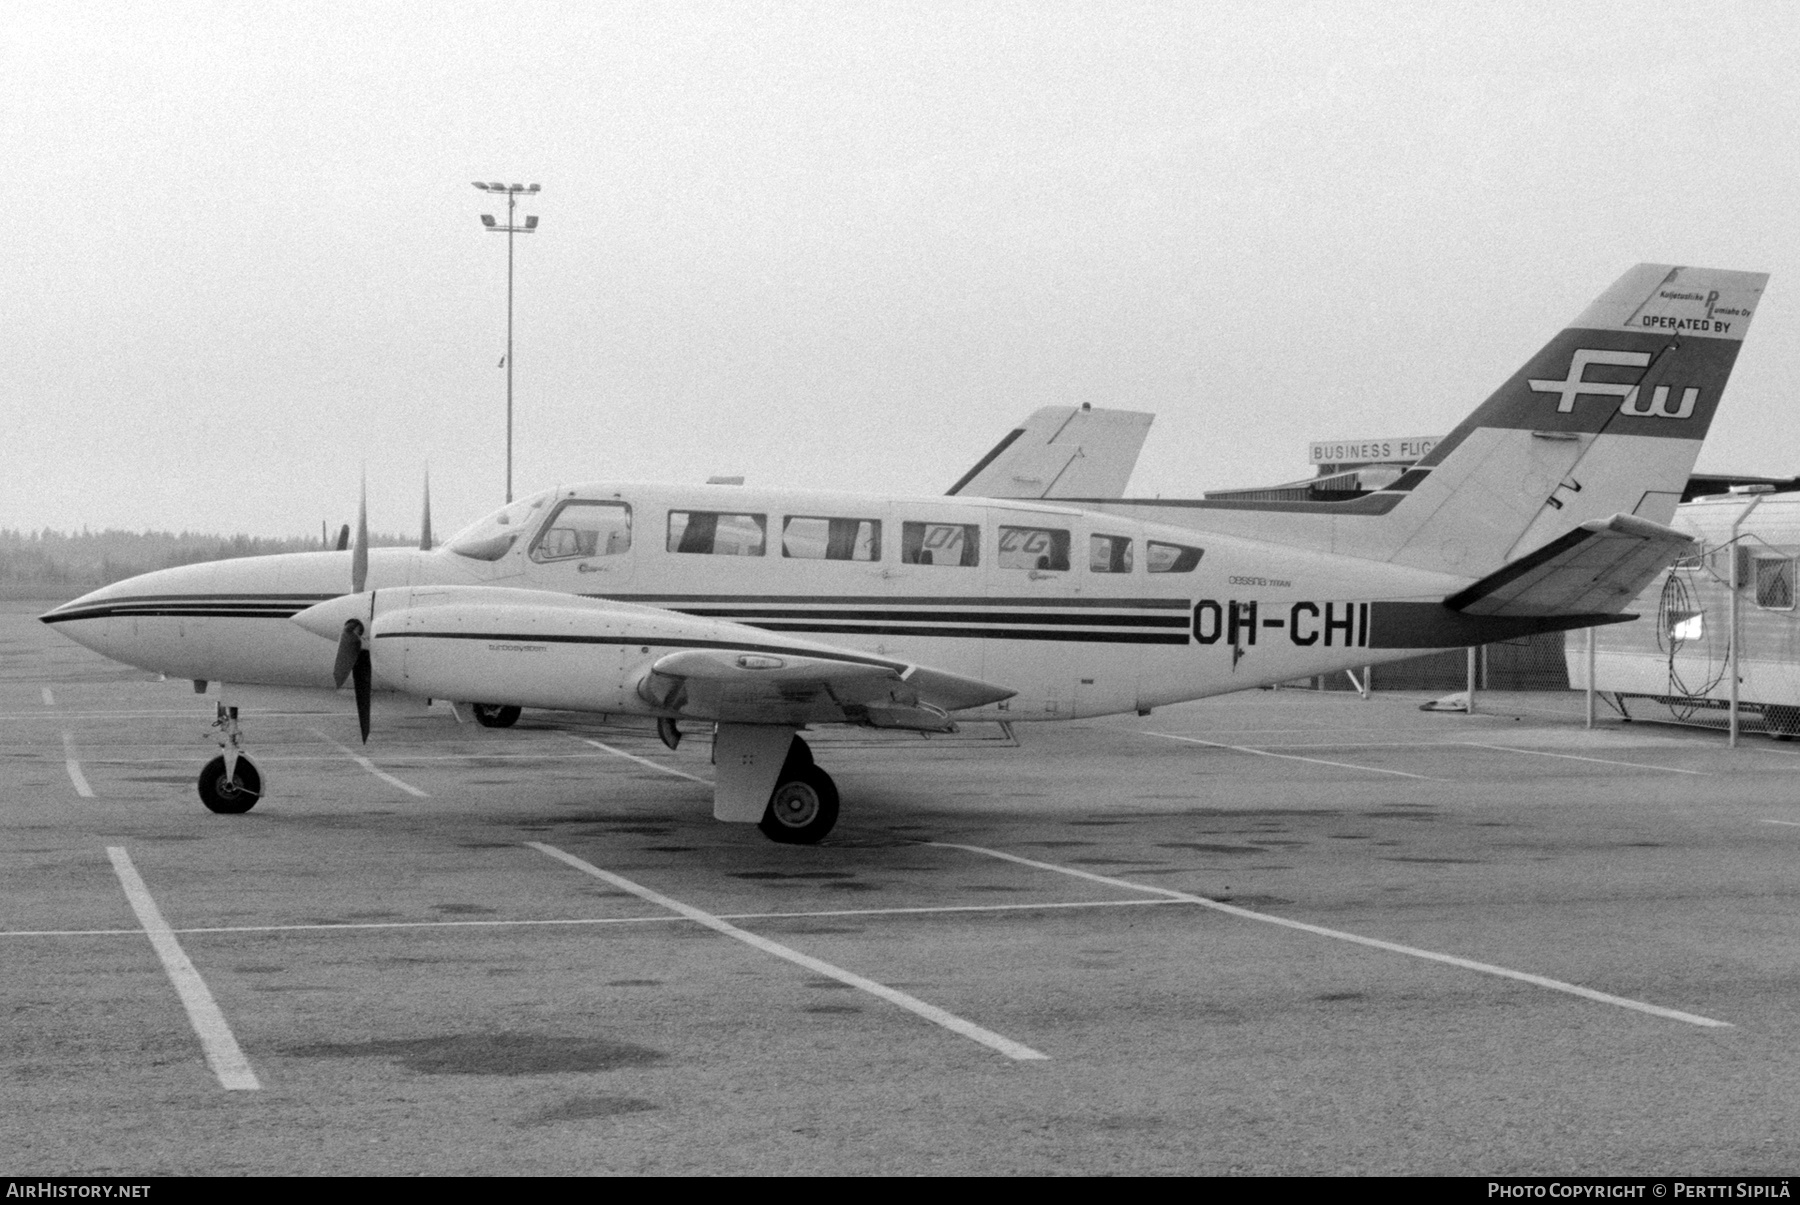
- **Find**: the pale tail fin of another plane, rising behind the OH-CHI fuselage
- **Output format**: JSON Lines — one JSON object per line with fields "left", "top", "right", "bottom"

{"left": 949, "top": 405, "right": 1156, "bottom": 497}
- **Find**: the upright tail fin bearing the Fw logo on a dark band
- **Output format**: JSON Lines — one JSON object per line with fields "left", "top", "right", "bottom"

{"left": 1096, "top": 263, "right": 1768, "bottom": 578}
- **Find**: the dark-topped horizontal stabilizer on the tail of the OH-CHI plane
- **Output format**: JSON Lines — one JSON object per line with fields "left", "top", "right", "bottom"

{"left": 1444, "top": 515, "right": 1694, "bottom": 616}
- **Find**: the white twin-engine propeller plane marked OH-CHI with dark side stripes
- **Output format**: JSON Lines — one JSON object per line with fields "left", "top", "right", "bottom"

{"left": 43, "top": 265, "right": 1768, "bottom": 843}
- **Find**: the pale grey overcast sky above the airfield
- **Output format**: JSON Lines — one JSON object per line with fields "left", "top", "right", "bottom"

{"left": 0, "top": 0, "right": 1800, "bottom": 535}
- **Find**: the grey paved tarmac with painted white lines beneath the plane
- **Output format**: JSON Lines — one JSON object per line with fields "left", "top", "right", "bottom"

{"left": 0, "top": 603, "right": 1800, "bottom": 1174}
